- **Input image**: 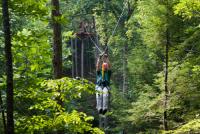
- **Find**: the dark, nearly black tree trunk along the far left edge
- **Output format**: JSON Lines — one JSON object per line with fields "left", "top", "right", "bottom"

{"left": 2, "top": 0, "right": 14, "bottom": 134}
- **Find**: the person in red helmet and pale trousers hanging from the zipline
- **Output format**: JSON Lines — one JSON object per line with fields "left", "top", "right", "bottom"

{"left": 96, "top": 54, "right": 111, "bottom": 114}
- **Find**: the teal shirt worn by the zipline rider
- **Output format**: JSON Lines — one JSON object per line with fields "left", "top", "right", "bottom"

{"left": 96, "top": 70, "right": 111, "bottom": 87}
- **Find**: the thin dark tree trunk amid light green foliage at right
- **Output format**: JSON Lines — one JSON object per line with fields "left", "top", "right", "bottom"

{"left": 163, "top": 29, "right": 170, "bottom": 130}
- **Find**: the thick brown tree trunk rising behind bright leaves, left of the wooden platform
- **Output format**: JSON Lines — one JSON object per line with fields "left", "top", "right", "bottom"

{"left": 52, "top": 0, "right": 62, "bottom": 79}
